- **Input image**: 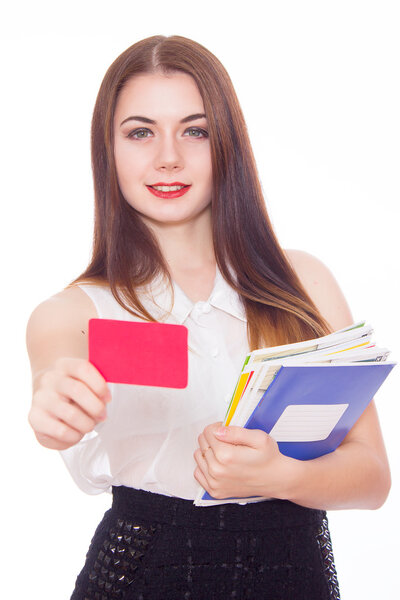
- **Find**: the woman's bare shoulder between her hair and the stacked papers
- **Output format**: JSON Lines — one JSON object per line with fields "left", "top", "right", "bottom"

{"left": 285, "top": 249, "right": 353, "bottom": 330}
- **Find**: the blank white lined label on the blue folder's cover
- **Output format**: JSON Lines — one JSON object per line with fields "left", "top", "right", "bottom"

{"left": 269, "top": 404, "right": 348, "bottom": 442}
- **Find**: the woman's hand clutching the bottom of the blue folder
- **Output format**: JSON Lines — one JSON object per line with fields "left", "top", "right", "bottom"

{"left": 194, "top": 423, "right": 297, "bottom": 499}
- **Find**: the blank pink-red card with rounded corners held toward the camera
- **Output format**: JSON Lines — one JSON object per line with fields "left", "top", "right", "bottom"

{"left": 89, "top": 319, "right": 188, "bottom": 388}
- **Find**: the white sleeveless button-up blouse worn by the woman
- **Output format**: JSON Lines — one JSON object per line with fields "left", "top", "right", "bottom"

{"left": 61, "top": 269, "right": 249, "bottom": 500}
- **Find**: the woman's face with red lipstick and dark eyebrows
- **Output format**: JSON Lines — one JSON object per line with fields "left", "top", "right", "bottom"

{"left": 114, "top": 72, "right": 212, "bottom": 229}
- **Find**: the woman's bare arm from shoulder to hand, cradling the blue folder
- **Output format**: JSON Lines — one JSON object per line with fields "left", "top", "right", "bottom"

{"left": 195, "top": 251, "right": 390, "bottom": 509}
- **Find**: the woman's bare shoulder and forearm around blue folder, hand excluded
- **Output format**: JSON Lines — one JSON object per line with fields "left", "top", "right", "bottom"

{"left": 282, "top": 251, "right": 390, "bottom": 509}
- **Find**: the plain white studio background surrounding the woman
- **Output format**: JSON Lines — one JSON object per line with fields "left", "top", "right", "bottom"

{"left": 0, "top": 0, "right": 400, "bottom": 600}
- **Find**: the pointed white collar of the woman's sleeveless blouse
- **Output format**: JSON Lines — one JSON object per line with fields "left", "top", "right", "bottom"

{"left": 140, "top": 267, "right": 247, "bottom": 325}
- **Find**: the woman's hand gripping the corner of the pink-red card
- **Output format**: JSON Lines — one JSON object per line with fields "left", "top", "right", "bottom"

{"left": 28, "top": 358, "right": 111, "bottom": 450}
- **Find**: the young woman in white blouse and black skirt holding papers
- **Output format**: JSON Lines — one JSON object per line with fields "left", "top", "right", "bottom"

{"left": 27, "top": 36, "right": 390, "bottom": 600}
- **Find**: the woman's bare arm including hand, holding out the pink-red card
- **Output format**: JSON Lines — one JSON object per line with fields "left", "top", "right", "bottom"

{"left": 26, "top": 287, "right": 110, "bottom": 450}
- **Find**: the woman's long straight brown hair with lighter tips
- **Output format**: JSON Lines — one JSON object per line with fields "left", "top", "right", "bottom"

{"left": 70, "top": 36, "right": 329, "bottom": 349}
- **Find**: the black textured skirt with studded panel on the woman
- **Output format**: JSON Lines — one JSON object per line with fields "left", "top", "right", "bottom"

{"left": 71, "top": 487, "right": 340, "bottom": 600}
